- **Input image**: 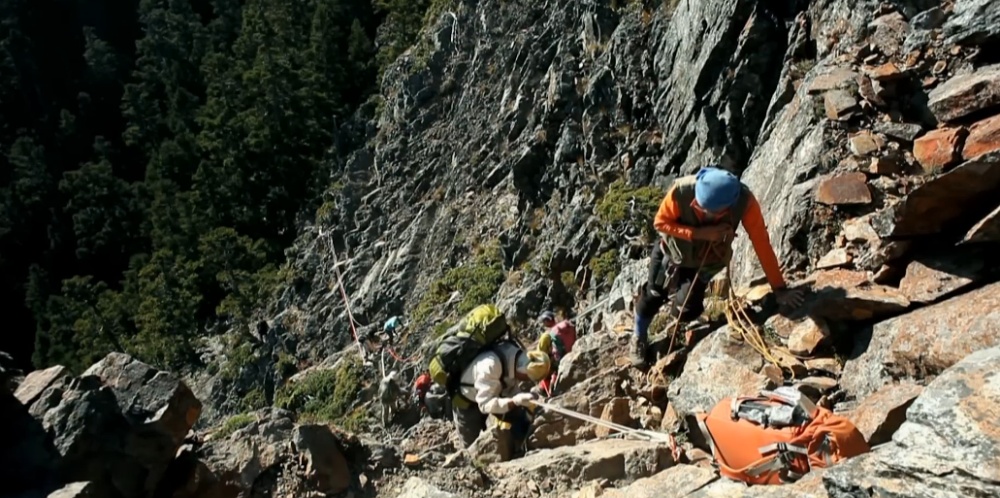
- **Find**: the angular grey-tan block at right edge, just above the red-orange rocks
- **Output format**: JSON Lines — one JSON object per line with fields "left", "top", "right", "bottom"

{"left": 927, "top": 63, "right": 1000, "bottom": 122}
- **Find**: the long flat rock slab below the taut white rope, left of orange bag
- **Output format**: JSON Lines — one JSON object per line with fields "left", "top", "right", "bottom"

{"left": 490, "top": 439, "right": 676, "bottom": 486}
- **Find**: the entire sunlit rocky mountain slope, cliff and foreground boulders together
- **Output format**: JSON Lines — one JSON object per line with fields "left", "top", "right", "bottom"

{"left": 4, "top": 0, "right": 1000, "bottom": 498}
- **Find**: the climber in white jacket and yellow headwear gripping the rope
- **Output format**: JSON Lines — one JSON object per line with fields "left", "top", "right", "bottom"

{"left": 452, "top": 342, "right": 550, "bottom": 446}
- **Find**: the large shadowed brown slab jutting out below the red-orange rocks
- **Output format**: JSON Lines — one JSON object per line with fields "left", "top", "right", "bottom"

{"left": 877, "top": 151, "right": 1000, "bottom": 237}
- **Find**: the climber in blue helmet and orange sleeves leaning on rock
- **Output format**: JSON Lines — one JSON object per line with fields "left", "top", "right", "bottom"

{"left": 629, "top": 166, "right": 802, "bottom": 367}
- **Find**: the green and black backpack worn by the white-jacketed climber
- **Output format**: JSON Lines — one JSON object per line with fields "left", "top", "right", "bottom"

{"left": 428, "top": 304, "right": 510, "bottom": 396}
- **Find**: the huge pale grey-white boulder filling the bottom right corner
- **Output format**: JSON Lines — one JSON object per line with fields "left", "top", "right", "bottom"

{"left": 824, "top": 344, "right": 1000, "bottom": 497}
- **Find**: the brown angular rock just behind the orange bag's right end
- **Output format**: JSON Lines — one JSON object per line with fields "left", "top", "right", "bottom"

{"left": 849, "top": 382, "right": 924, "bottom": 446}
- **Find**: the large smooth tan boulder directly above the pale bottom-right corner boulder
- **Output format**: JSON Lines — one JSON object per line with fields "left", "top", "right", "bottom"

{"left": 840, "top": 283, "right": 1000, "bottom": 399}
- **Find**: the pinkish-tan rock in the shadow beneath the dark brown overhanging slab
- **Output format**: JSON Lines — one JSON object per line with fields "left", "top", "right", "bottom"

{"left": 899, "top": 257, "right": 983, "bottom": 303}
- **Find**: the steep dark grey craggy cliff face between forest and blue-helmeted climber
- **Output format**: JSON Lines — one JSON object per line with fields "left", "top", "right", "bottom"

{"left": 260, "top": 0, "right": 812, "bottom": 368}
